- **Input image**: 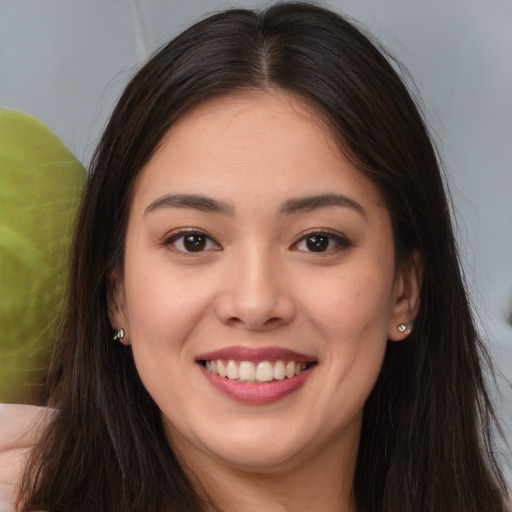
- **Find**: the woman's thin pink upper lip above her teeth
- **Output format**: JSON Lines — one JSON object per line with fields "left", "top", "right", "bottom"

{"left": 196, "top": 345, "right": 316, "bottom": 363}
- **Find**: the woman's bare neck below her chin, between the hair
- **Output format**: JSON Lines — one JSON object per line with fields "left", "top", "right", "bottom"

{"left": 176, "top": 428, "right": 358, "bottom": 512}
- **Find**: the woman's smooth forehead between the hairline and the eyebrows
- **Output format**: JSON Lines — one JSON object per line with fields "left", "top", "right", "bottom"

{"left": 133, "top": 91, "right": 383, "bottom": 212}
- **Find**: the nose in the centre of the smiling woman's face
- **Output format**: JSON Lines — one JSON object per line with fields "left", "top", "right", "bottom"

{"left": 216, "top": 252, "right": 295, "bottom": 331}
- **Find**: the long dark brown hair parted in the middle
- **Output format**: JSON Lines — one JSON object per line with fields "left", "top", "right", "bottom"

{"left": 20, "top": 3, "right": 505, "bottom": 512}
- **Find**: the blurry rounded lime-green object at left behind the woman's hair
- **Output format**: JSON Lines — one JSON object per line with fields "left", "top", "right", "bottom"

{"left": 0, "top": 109, "right": 85, "bottom": 403}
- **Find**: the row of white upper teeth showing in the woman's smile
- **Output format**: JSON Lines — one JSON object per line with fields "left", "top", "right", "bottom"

{"left": 205, "top": 359, "right": 306, "bottom": 382}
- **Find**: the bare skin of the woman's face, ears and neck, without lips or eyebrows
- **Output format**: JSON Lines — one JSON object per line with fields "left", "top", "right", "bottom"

{"left": 110, "top": 91, "right": 420, "bottom": 512}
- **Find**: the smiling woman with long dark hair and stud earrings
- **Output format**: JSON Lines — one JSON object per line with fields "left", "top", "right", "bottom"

{"left": 1, "top": 4, "right": 505, "bottom": 512}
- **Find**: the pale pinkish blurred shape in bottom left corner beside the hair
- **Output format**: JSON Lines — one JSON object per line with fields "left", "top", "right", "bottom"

{"left": 0, "top": 404, "right": 54, "bottom": 512}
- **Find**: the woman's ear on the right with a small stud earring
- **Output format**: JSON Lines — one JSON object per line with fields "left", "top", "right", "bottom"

{"left": 388, "top": 250, "right": 423, "bottom": 341}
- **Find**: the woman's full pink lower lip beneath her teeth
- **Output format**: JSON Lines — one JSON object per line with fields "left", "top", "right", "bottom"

{"left": 200, "top": 366, "right": 314, "bottom": 405}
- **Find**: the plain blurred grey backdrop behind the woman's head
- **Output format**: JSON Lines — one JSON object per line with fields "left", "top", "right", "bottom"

{"left": 0, "top": 0, "right": 512, "bottom": 481}
